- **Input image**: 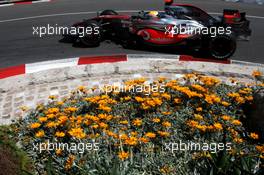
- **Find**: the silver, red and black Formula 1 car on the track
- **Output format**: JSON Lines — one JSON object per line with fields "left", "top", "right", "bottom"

{"left": 63, "top": 1, "right": 251, "bottom": 59}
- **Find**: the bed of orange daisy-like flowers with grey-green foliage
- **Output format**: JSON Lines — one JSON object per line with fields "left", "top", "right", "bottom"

{"left": 16, "top": 72, "right": 264, "bottom": 175}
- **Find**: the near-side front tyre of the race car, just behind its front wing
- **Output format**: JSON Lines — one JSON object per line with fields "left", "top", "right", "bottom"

{"left": 79, "top": 20, "right": 102, "bottom": 47}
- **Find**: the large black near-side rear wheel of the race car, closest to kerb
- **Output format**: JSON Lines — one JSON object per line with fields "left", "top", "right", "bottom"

{"left": 209, "top": 35, "right": 236, "bottom": 60}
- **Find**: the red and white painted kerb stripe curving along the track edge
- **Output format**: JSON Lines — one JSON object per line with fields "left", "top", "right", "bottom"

{"left": 0, "top": 54, "right": 264, "bottom": 79}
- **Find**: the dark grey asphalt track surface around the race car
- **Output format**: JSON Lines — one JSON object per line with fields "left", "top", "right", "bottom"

{"left": 0, "top": 0, "right": 264, "bottom": 68}
